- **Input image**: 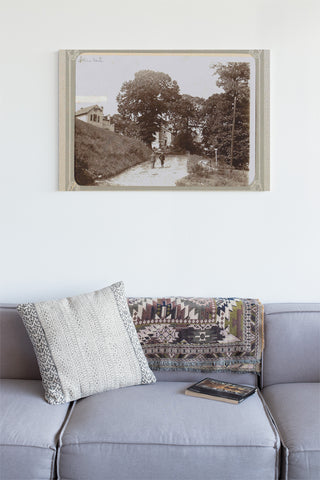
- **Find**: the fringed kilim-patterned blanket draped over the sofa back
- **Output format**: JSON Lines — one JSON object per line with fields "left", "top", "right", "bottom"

{"left": 128, "top": 297, "right": 263, "bottom": 374}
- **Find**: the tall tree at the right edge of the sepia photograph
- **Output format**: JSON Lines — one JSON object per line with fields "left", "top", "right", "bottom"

{"left": 208, "top": 62, "right": 250, "bottom": 167}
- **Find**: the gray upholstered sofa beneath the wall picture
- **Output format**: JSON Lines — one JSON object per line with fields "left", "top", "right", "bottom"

{"left": 0, "top": 304, "right": 320, "bottom": 480}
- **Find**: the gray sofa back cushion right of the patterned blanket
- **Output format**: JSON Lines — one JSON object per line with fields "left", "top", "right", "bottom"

{"left": 262, "top": 303, "right": 320, "bottom": 386}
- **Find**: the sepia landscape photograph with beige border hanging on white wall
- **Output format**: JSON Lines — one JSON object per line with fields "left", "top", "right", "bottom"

{"left": 59, "top": 50, "right": 270, "bottom": 191}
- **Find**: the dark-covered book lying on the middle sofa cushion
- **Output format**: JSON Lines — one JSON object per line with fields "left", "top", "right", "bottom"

{"left": 185, "top": 378, "right": 256, "bottom": 404}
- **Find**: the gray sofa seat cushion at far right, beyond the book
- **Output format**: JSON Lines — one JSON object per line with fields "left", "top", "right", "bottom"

{"left": 263, "top": 383, "right": 320, "bottom": 480}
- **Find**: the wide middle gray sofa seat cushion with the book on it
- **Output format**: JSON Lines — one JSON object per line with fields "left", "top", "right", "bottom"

{"left": 58, "top": 382, "right": 280, "bottom": 480}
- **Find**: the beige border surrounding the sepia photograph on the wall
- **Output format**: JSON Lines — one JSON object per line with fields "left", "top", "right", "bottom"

{"left": 59, "top": 50, "right": 270, "bottom": 191}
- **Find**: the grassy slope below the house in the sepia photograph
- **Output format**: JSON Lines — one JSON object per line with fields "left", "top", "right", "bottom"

{"left": 75, "top": 119, "right": 150, "bottom": 185}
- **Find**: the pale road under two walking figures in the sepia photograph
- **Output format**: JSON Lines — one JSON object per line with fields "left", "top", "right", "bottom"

{"left": 100, "top": 155, "right": 188, "bottom": 187}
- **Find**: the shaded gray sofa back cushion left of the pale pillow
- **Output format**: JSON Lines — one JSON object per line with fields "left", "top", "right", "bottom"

{"left": 0, "top": 304, "right": 41, "bottom": 380}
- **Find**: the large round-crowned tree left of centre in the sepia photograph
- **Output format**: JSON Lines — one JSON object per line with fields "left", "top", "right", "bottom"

{"left": 117, "top": 70, "right": 179, "bottom": 145}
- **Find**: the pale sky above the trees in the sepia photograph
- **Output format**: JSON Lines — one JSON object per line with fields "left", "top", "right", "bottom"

{"left": 76, "top": 53, "right": 254, "bottom": 115}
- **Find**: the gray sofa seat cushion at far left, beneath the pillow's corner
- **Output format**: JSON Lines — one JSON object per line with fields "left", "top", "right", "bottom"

{"left": 0, "top": 380, "right": 68, "bottom": 480}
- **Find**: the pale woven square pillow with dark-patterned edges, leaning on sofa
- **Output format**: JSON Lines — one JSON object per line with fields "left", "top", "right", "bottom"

{"left": 18, "top": 282, "right": 155, "bottom": 404}
